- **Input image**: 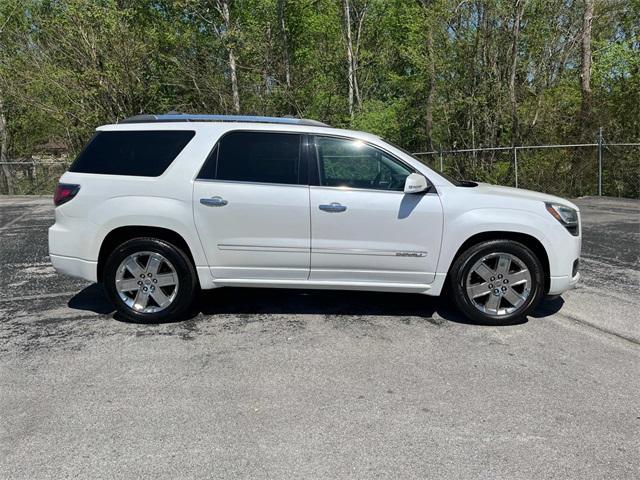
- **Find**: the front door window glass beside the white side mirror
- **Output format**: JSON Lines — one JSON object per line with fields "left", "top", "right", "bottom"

{"left": 316, "top": 137, "right": 411, "bottom": 191}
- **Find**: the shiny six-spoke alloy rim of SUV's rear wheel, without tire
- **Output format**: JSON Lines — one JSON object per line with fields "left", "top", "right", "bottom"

{"left": 116, "top": 252, "right": 179, "bottom": 313}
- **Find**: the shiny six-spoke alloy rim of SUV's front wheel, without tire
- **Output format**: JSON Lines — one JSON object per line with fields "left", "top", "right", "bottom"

{"left": 466, "top": 252, "right": 532, "bottom": 316}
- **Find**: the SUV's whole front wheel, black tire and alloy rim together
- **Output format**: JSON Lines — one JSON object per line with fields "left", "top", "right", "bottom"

{"left": 450, "top": 240, "right": 544, "bottom": 325}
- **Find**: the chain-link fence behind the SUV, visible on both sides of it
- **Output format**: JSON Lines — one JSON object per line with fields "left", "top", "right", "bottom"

{"left": 0, "top": 142, "right": 640, "bottom": 198}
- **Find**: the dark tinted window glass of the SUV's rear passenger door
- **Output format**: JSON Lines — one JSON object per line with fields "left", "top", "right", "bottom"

{"left": 212, "top": 132, "right": 306, "bottom": 184}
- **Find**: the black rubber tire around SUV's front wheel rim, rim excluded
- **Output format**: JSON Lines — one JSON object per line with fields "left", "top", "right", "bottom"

{"left": 449, "top": 240, "right": 544, "bottom": 325}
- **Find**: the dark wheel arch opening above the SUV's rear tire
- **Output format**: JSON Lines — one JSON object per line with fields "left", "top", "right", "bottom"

{"left": 97, "top": 225, "right": 196, "bottom": 282}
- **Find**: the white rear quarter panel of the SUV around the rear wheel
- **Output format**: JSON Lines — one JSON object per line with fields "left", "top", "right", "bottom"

{"left": 49, "top": 124, "right": 212, "bottom": 288}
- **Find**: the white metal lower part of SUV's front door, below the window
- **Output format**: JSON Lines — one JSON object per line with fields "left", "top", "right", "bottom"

{"left": 309, "top": 186, "right": 442, "bottom": 284}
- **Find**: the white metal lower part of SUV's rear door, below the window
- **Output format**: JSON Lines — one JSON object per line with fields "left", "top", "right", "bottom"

{"left": 193, "top": 180, "right": 311, "bottom": 281}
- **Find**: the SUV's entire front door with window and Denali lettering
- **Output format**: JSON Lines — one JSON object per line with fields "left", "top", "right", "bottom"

{"left": 310, "top": 136, "right": 442, "bottom": 284}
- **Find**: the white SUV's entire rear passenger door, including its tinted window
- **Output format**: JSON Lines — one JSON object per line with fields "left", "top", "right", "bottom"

{"left": 193, "top": 131, "right": 311, "bottom": 280}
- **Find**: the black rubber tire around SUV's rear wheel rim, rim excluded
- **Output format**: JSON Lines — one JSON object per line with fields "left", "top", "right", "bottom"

{"left": 102, "top": 237, "right": 198, "bottom": 323}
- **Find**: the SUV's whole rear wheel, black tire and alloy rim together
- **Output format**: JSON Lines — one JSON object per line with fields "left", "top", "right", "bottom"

{"left": 103, "top": 238, "right": 197, "bottom": 323}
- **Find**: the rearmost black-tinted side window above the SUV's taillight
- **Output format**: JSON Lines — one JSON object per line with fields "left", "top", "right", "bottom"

{"left": 70, "top": 130, "right": 195, "bottom": 177}
